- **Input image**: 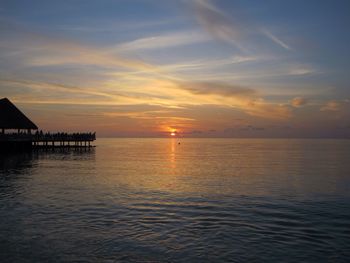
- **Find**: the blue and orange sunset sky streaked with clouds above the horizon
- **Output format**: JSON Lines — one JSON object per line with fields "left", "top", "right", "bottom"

{"left": 0, "top": 0, "right": 350, "bottom": 138}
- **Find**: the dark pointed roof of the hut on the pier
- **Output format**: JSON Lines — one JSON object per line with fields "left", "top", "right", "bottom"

{"left": 0, "top": 98, "right": 38, "bottom": 130}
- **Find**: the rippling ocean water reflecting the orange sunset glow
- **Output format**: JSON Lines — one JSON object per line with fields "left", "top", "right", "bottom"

{"left": 0, "top": 138, "right": 350, "bottom": 262}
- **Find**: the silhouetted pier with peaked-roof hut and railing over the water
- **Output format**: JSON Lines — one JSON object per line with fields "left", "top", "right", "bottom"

{"left": 0, "top": 98, "right": 96, "bottom": 152}
